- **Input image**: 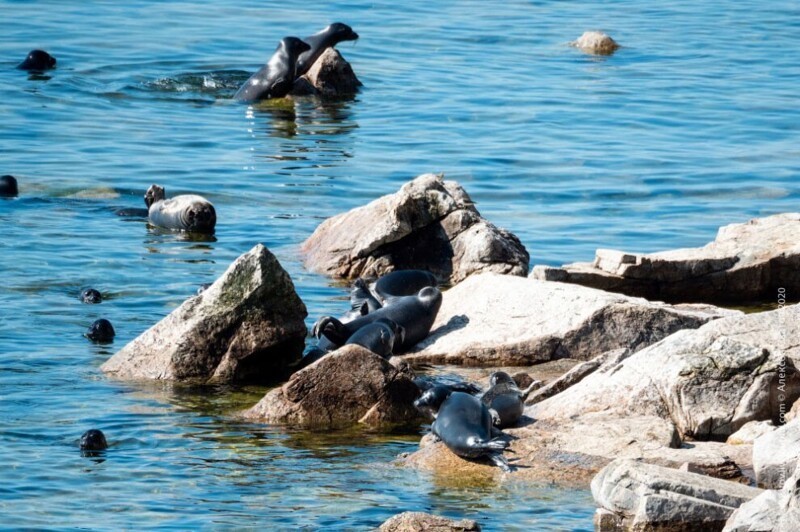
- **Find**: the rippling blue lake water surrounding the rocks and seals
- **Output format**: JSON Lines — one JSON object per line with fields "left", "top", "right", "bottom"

{"left": 0, "top": 0, "right": 800, "bottom": 530}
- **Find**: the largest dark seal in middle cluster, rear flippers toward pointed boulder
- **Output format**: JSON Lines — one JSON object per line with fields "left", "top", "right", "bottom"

{"left": 311, "top": 286, "right": 442, "bottom": 354}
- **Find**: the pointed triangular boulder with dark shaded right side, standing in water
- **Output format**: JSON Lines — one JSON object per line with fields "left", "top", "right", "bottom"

{"left": 101, "top": 244, "right": 308, "bottom": 383}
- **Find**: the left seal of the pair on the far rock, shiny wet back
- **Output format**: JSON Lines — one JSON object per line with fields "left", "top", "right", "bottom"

{"left": 233, "top": 37, "right": 311, "bottom": 102}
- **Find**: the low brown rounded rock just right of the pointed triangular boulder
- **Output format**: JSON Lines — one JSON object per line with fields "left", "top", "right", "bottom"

{"left": 243, "top": 345, "right": 421, "bottom": 428}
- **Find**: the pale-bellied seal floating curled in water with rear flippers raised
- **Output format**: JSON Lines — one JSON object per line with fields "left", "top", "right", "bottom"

{"left": 144, "top": 185, "right": 217, "bottom": 233}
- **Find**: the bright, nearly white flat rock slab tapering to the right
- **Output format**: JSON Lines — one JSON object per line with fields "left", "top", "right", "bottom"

{"left": 404, "top": 273, "right": 739, "bottom": 366}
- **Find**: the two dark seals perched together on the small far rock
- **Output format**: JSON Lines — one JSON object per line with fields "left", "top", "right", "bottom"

{"left": 233, "top": 22, "right": 358, "bottom": 102}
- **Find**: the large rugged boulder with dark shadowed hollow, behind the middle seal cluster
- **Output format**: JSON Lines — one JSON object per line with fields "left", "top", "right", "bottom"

{"left": 302, "top": 174, "right": 529, "bottom": 282}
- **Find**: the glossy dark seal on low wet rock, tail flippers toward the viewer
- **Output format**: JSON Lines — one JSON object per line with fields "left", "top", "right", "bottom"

{"left": 414, "top": 386, "right": 511, "bottom": 472}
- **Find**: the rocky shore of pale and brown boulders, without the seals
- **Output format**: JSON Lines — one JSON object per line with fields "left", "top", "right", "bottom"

{"left": 102, "top": 174, "right": 800, "bottom": 531}
